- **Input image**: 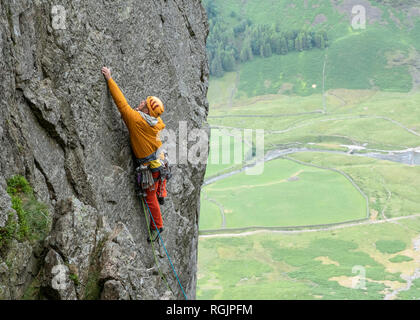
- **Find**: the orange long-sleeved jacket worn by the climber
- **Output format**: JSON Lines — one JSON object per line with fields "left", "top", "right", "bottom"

{"left": 108, "top": 78, "right": 165, "bottom": 159}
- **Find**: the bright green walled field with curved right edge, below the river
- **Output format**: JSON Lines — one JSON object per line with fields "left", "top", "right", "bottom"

{"left": 200, "top": 159, "right": 367, "bottom": 229}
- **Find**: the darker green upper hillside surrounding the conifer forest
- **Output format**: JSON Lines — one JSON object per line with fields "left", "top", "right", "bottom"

{"left": 205, "top": 0, "right": 420, "bottom": 98}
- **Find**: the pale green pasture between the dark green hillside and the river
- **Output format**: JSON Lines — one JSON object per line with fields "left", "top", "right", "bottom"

{"left": 209, "top": 89, "right": 420, "bottom": 150}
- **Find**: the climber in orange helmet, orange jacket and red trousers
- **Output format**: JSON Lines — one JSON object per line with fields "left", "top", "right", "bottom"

{"left": 102, "top": 67, "right": 169, "bottom": 242}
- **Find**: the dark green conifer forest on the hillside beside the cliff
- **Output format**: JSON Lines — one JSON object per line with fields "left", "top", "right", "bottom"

{"left": 203, "top": 0, "right": 328, "bottom": 77}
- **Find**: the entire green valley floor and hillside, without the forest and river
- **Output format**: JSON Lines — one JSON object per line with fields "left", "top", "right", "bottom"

{"left": 197, "top": 0, "right": 420, "bottom": 299}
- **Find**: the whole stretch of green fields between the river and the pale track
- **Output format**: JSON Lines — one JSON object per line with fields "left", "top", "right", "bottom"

{"left": 200, "top": 152, "right": 420, "bottom": 230}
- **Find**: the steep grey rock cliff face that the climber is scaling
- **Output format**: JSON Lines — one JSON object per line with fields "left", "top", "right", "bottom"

{"left": 0, "top": 0, "right": 208, "bottom": 299}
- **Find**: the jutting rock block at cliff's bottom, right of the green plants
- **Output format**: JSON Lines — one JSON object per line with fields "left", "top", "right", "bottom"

{"left": 41, "top": 198, "right": 175, "bottom": 300}
